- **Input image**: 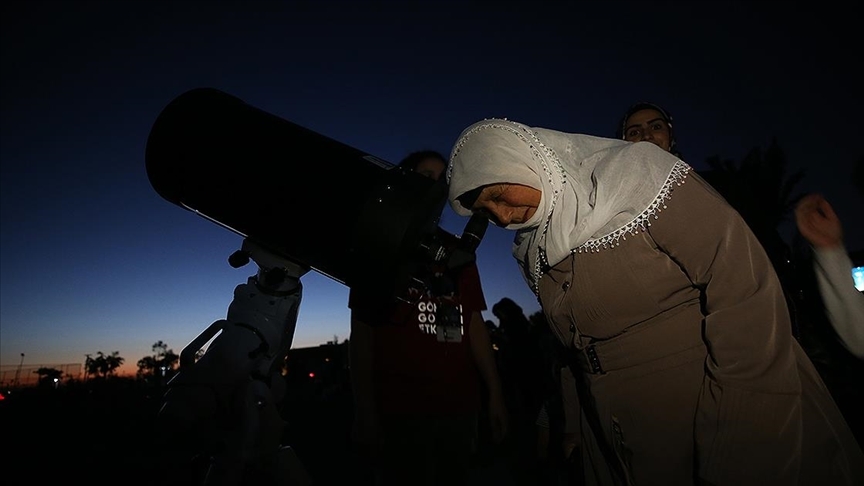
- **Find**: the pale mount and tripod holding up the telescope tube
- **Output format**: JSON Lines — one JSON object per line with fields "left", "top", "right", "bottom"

{"left": 159, "top": 238, "right": 311, "bottom": 486}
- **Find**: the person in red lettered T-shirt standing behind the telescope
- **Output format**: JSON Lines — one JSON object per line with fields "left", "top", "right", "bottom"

{"left": 349, "top": 151, "right": 507, "bottom": 486}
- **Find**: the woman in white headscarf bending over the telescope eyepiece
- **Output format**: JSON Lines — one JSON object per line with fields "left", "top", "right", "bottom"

{"left": 447, "top": 119, "right": 864, "bottom": 486}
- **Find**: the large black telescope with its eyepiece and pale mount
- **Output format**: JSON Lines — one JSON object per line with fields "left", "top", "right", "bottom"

{"left": 145, "top": 88, "right": 488, "bottom": 486}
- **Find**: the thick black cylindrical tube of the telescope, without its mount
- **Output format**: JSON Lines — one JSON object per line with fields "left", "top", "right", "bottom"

{"left": 145, "top": 88, "right": 446, "bottom": 294}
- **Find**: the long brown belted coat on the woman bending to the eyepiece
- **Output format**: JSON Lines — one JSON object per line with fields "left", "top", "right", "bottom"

{"left": 538, "top": 173, "right": 864, "bottom": 486}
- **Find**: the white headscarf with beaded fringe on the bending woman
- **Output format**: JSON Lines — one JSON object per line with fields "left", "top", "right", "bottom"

{"left": 447, "top": 119, "right": 690, "bottom": 293}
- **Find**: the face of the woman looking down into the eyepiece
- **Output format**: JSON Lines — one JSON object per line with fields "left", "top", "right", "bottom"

{"left": 471, "top": 183, "right": 541, "bottom": 227}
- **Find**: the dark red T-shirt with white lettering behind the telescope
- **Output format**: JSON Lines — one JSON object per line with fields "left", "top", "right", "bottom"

{"left": 348, "top": 263, "right": 486, "bottom": 414}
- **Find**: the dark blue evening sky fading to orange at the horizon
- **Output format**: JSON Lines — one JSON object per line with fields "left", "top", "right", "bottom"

{"left": 0, "top": 0, "right": 864, "bottom": 376}
